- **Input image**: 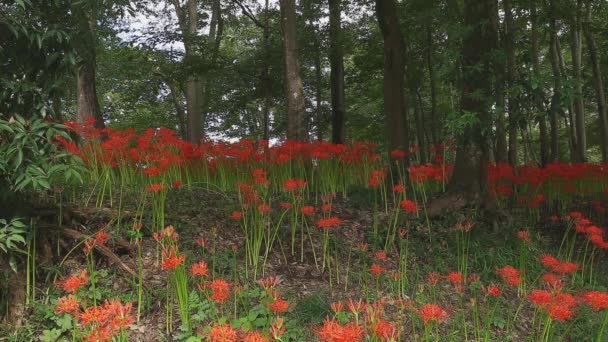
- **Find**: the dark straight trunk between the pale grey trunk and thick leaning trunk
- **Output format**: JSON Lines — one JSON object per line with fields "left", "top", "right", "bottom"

{"left": 329, "top": 0, "right": 346, "bottom": 144}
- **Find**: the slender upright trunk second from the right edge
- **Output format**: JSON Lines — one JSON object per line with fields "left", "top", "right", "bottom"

{"left": 570, "top": 0, "right": 587, "bottom": 162}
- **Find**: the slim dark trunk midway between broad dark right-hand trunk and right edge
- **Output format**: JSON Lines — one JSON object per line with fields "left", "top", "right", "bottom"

{"left": 530, "top": 0, "right": 549, "bottom": 166}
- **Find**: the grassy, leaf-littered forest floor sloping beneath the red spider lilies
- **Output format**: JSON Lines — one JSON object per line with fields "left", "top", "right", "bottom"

{"left": 0, "top": 189, "right": 608, "bottom": 341}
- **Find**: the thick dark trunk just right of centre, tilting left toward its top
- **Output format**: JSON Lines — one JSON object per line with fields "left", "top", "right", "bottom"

{"left": 376, "top": 0, "right": 409, "bottom": 163}
